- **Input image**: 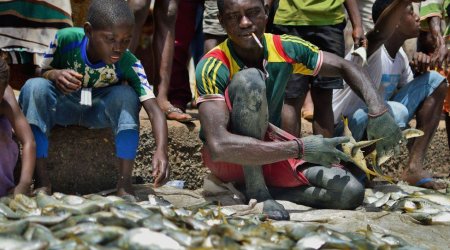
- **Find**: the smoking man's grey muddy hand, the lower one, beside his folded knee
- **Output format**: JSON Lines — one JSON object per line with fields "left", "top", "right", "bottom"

{"left": 300, "top": 135, "right": 351, "bottom": 167}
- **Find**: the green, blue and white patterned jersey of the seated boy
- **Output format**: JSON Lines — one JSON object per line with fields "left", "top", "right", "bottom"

{"left": 41, "top": 28, "right": 155, "bottom": 102}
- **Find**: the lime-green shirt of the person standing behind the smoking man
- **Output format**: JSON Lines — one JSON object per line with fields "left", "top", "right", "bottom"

{"left": 273, "top": 0, "right": 345, "bottom": 26}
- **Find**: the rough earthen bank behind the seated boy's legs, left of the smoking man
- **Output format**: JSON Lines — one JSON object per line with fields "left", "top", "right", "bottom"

{"left": 44, "top": 117, "right": 208, "bottom": 194}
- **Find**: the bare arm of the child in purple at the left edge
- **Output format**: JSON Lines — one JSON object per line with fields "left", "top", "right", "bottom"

{"left": 4, "top": 86, "right": 36, "bottom": 194}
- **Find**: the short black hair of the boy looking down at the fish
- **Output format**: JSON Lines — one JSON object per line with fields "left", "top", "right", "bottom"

{"left": 86, "top": 0, "right": 134, "bottom": 29}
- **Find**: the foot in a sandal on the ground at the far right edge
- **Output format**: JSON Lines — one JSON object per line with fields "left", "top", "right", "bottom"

{"left": 402, "top": 169, "right": 447, "bottom": 190}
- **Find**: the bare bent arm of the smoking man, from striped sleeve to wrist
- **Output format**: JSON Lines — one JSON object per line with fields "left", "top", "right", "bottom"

{"left": 199, "top": 101, "right": 298, "bottom": 165}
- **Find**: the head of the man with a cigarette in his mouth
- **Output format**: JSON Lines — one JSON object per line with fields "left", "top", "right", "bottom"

{"left": 217, "top": 0, "right": 268, "bottom": 49}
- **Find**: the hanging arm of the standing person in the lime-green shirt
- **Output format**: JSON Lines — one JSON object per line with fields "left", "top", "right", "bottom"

{"left": 344, "top": 0, "right": 367, "bottom": 49}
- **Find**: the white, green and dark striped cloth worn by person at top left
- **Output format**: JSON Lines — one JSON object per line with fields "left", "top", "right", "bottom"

{"left": 0, "top": 0, "right": 72, "bottom": 64}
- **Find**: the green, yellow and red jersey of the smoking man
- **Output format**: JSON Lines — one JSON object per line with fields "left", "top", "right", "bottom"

{"left": 196, "top": 33, "right": 322, "bottom": 126}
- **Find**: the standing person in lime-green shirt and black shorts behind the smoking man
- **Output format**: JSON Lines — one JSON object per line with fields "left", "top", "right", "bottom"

{"left": 272, "top": 0, "right": 365, "bottom": 137}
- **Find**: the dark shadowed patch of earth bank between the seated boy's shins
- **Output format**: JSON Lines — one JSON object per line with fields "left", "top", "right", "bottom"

{"left": 47, "top": 126, "right": 119, "bottom": 194}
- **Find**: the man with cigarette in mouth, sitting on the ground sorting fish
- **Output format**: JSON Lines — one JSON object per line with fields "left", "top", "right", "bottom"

{"left": 196, "top": 0, "right": 402, "bottom": 220}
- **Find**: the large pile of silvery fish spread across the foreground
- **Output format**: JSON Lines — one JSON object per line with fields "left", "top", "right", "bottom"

{"left": 0, "top": 193, "right": 424, "bottom": 250}
